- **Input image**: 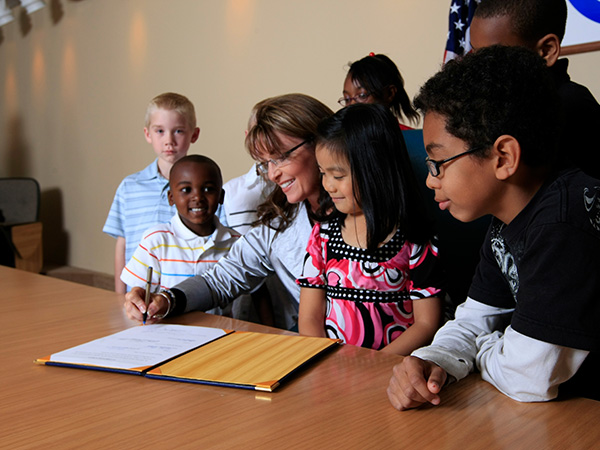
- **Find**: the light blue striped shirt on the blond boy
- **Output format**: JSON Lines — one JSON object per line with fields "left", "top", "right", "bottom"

{"left": 102, "top": 159, "right": 177, "bottom": 261}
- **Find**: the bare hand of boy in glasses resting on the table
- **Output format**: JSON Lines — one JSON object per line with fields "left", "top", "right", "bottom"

{"left": 387, "top": 356, "right": 447, "bottom": 411}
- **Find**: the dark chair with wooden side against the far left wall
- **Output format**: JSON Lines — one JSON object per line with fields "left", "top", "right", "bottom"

{"left": 0, "top": 178, "right": 42, "bottom": 272}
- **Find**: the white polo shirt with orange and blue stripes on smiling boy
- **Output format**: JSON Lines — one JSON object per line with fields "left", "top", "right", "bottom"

{"left": 121, "top": 214, "right": 250, "bottom": 318}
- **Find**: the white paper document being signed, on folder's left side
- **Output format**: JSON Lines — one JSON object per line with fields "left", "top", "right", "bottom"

{"left": 50, "top": 324, "right": 227, "bottom": 370}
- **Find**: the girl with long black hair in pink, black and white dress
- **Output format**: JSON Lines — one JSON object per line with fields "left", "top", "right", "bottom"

{"left": 298, "top": 104, "right": 443, "bottom": 355}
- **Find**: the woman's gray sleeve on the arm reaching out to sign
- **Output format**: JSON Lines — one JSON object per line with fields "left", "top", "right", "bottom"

{"left": 175, "top": 225, "right": 275, "bottom": 312}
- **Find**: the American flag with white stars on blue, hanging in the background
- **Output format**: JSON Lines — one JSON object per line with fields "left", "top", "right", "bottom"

{"left": 444, "top": 0, "right": 481, "bottom": 64}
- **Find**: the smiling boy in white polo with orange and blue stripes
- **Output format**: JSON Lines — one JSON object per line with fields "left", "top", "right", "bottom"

{"left": 121, "top": 155, "right": 251, "bottom": 320}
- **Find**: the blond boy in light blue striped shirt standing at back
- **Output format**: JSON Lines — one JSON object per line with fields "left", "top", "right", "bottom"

{"left": 102, "top": 92, "right": 200, "bottom": 294}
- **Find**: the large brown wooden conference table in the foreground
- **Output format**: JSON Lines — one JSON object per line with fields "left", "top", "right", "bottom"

{"left": 0, "top": 266, "right": 600, "bottom": 449}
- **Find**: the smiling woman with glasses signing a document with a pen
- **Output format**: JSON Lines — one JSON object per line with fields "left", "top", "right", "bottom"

{"left": 125, "top": 94, "right": 333, "bottom": 329}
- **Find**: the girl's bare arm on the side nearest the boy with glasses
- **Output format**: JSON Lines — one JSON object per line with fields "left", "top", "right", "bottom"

{"left": 382, "top": 297, "right": 442, "bottom": 355}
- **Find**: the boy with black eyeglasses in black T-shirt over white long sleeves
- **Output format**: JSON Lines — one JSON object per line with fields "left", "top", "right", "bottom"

{"left": 388, "top": 46, "right": 600, "bottom": 410}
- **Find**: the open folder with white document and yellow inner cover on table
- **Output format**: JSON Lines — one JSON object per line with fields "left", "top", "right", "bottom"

{"left": 35, "top": 324, "right": 340, "bottom": 392}
